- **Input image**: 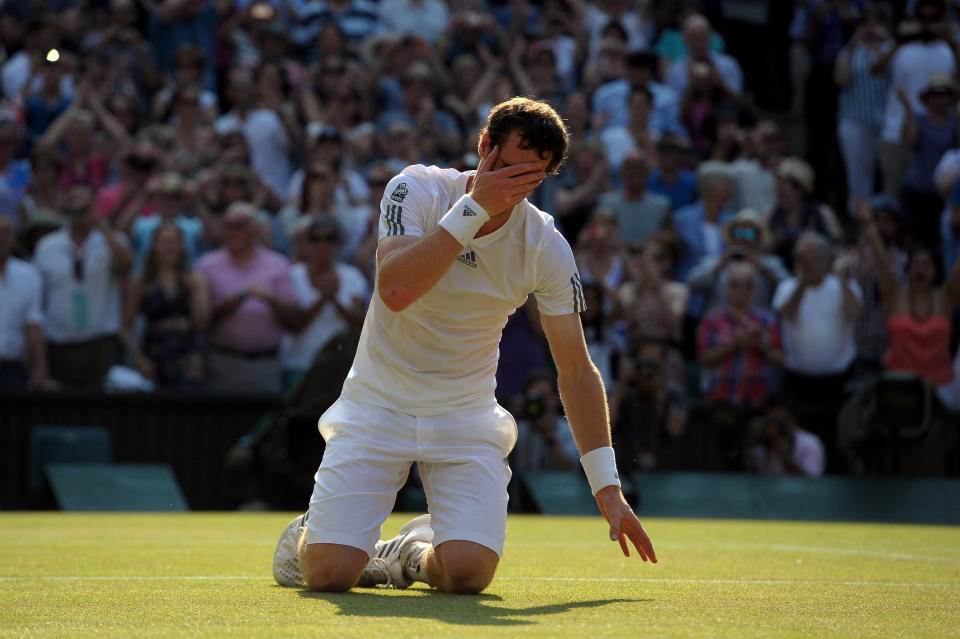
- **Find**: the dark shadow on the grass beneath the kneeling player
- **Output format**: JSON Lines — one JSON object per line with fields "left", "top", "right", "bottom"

{"left": 300, "top": 589, "right": 652, "bottom": 626}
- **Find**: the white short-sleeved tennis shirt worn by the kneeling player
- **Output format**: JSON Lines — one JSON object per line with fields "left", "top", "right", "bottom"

{"left": 342, "top": 164, "right": 585, "bottom": 416}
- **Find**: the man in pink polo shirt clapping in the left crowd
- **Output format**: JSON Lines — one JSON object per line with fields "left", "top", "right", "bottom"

{"left": 196, "top": 202, "right": 300, "bottom": 393}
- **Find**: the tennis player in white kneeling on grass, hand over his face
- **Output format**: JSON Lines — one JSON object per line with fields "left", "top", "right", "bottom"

{"left": 274, "top": 98, "right": 656, "bottom": 593}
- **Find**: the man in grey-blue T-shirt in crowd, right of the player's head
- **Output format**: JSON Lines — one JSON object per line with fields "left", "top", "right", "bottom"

{"left": 597, "top": 150, "right": 670, "bottom": 244}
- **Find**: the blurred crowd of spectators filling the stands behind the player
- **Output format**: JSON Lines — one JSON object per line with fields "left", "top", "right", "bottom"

{"left": 0, "top": 0, "right": 960, "bottom": 496}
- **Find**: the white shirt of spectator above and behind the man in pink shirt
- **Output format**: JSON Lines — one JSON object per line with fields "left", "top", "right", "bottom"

{"left": 214, "top": 109, "right": 293, "bottom": 195}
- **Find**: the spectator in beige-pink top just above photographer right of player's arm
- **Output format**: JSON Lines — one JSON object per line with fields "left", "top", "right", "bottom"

{"left": 617, "top": 238, "right": 690, "bottom": 387}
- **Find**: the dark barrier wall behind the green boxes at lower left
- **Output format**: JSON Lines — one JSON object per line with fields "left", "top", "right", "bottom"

{"left": 0, "top": 392, "right": 279, "bottom": 510}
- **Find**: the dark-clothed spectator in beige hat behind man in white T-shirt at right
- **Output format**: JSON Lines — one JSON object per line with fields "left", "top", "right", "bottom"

{"left": 767, "top": 157, "right": 842, "bottom": 270}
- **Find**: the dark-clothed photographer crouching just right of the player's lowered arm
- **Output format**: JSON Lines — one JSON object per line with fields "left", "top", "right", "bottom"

{"left": 610, "top": 340, "right": 687, "bottom": 473}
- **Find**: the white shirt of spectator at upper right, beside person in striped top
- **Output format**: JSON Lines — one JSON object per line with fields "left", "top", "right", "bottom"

{"left": 880, "top": 40, "right": 957, "bottom": 143}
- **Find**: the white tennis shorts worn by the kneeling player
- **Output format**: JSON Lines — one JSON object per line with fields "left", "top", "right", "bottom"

{"left": 307, "top": 398, "right": 517, "bottom": 556}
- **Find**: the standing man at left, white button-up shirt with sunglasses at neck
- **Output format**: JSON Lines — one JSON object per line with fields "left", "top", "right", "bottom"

{"left": 33, "top": 182, "right": 133, "bottom": 386}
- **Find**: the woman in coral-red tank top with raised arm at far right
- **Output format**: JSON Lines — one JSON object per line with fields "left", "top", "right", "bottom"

{"left": 857, "top": 202, "right": 960, "bottom": 387}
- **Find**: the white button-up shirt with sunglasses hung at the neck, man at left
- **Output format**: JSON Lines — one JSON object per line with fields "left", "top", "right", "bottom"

{"left": 33, "top": 229, "right": 130, "bottom": 344}
